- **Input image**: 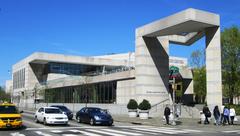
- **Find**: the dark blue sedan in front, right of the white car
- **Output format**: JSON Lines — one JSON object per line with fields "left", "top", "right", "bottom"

{"left": 76, "top": 107, "right": 113, "bottom": 126}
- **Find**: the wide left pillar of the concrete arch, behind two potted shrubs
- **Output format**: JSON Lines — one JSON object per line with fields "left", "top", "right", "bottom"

{"left": 135, "top": 34, "right": 169, "bottom": 104}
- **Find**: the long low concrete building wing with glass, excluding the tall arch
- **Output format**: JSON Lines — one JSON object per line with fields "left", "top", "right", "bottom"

{"left": 10, "top": 53, "right": 193, "bottom": 107}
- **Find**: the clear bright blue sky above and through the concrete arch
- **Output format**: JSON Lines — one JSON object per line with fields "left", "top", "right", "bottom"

{"left": 0, "top": 0, "right": 240, "bottom": 85}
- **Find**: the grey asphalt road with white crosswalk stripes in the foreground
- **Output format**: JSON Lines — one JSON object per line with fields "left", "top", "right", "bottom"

{"left": 0, "top": 113, "right": 240, "bottom": 136}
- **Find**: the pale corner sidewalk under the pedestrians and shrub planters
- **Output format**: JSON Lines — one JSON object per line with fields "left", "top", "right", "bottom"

{"left": 113, "top": 115, "right": 240, "bottom": 131}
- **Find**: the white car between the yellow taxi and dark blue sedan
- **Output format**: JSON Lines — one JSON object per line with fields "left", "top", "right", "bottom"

{"left": 34, "top": 107, "right": 68, "bottom": 125}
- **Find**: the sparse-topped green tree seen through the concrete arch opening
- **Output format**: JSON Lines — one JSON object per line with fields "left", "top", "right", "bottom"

{"left": 190, "top": 49, "right": 207, "bottom": 103}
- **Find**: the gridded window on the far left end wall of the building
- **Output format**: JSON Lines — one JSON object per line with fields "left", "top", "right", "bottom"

{"left": 13, "top": 68, "right": 25, "bottom": 89}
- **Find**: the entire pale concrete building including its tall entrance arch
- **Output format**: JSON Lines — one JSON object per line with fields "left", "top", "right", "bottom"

{"left": 9, "top": 9, "right": 222, "bottom": 115}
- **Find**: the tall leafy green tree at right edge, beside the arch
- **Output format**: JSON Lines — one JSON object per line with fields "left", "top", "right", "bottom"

{"left": 221, "top": 26, "right": 240, "bottom": 104}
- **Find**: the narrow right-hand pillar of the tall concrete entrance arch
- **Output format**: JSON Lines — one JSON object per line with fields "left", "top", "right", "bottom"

{"left": 206, "top": 27, "right": 222, "bottom": 109}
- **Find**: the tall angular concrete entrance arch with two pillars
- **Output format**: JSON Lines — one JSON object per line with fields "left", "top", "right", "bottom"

{"left": 135, "top": 8, "right": 222, "bottom": 108}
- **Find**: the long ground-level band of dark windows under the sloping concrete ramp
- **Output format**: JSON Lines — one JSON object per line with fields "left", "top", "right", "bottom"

{"left": 45, "top": 81, "right": 117, "bottom": 103}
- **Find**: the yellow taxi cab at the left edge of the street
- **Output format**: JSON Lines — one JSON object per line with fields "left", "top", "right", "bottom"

{"left": 0, "top": 102, "right": 22, "bottom": 128}
